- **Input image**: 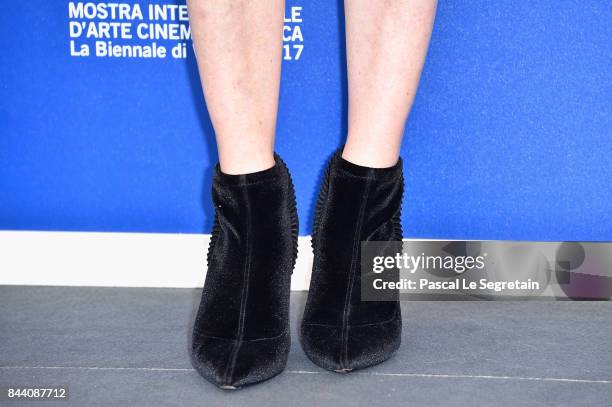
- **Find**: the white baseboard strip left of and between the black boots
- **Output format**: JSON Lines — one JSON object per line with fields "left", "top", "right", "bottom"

{"left": 0, "top": 231, "right": 312, "bottom": 290}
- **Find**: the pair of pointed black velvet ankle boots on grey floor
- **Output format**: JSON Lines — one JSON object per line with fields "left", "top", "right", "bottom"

{"left": 192, "top": 152, "right": 403, "bottom": 389}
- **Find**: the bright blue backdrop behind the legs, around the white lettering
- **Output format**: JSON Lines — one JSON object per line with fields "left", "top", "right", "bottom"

{"left": 0, "top": 0, "right": 612, "bottom": 240}
